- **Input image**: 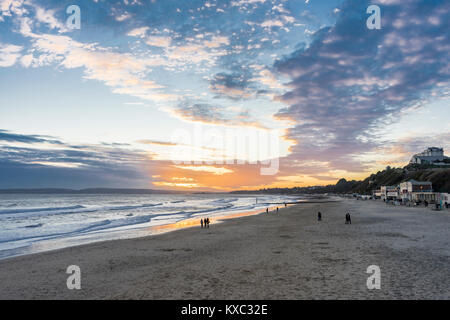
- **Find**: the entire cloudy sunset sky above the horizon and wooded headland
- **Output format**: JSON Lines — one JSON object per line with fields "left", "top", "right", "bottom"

{"left": 0, "top": 0, "right": 450, "bottom": 191}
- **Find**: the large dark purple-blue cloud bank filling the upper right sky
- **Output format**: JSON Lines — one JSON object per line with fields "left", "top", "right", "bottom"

{"left": 275, "top": 0, "right": 450, "bottom": 175}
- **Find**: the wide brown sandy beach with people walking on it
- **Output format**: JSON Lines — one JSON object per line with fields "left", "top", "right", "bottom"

{"left": 0, "top": 199, "right": 450, "bottom": 299}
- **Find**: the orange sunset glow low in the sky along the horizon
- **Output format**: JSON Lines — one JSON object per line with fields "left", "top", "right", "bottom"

{"left": 143, "top": 136, "right": 408, "bottom": 192}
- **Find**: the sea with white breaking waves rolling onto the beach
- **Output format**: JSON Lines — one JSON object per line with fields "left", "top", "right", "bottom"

{"left": 0, "top": 194, "right": 307, "bottom": 259}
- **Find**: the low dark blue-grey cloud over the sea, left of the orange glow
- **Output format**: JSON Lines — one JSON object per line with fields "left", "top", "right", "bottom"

{"left": 0, "top": 130, "right": 152, "bottom": 189}
